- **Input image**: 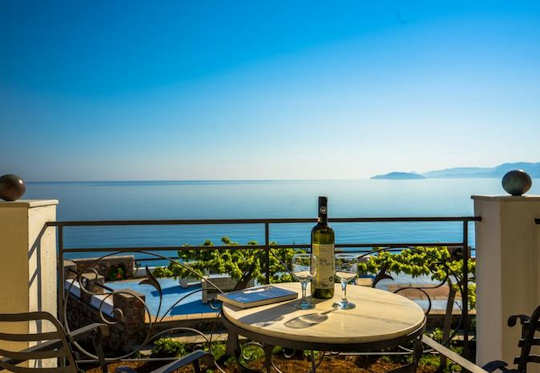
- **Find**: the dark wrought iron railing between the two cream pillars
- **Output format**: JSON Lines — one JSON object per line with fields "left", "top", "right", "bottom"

{"left": 43, "top": 216, "right": 480, "bottom": 370}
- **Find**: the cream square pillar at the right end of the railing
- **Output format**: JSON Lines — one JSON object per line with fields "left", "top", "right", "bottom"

{"left": 472, "top": 196, "right": 540, "bottom": 366}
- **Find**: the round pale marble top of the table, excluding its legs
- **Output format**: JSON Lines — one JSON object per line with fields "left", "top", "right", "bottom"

{"left": 223, "top": 283, "right": 425, "bottom": 344}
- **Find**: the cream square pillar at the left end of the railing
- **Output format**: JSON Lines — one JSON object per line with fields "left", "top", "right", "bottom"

{"left": 0, "top": 200, "right": 58, "bottom": 349}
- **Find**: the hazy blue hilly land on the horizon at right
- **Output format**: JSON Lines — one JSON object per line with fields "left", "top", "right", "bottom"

{"left": 372, "top": 162, "right": 540, "bottom": 180}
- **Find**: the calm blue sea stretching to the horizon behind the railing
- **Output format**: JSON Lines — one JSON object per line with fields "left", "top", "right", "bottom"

{"left": 25, "top": 179, "right": 540, "bottom": 260}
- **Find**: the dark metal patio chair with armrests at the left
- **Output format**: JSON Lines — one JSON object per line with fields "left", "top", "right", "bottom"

{"left": 0, "top": 312, "right": 210, "bottom": 373}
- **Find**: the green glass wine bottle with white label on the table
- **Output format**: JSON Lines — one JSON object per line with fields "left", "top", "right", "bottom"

{"left": 311, "top": 197, "right": 335, "bottom": 299}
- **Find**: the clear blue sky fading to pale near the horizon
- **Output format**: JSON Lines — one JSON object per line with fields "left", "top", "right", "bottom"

{"left": 0, "top": 0, "right": 540, "bottom": 180}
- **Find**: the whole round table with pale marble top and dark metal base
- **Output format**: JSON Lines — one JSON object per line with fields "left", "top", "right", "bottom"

{"left": 222, "top": 283, "right": 426, "bottom": 370}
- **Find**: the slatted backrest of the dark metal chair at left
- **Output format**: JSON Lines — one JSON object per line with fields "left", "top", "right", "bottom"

{"left": 0, "top": 312, "right": 77, "bottom": 373}
